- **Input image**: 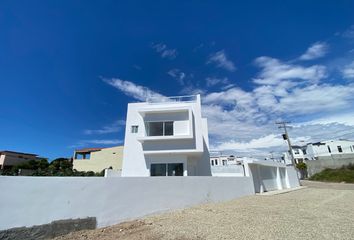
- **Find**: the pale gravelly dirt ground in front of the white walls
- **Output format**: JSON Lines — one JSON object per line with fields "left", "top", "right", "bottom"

{"left": 56, "top": 182, "right": 354, "bottom": 240}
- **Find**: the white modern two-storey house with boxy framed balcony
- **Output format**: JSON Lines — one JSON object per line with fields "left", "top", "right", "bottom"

{"left": 122, "top": 95, "right": 211, "bottom": 176}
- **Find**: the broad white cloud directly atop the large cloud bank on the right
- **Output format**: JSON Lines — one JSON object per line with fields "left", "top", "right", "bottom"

{"left": 253, "top": 56, "right": 327, "bottom": 85}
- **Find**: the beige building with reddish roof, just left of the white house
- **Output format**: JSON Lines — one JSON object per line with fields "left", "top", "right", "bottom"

{"left": 73, "top": 146, "right": 123, "bottom": 172}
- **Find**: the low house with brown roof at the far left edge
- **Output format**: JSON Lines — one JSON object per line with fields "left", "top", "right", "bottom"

{"left": 0, "top": 150, "right": 38, "bottom": 169}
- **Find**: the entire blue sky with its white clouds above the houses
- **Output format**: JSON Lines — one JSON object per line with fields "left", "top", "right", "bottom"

{"left": 0, "top": 1, "right": 354, "bottom": 159}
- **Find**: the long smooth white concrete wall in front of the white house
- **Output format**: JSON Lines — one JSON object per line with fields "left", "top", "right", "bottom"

{"left": 0, "top": 176, "right": 255, "bottom": 230}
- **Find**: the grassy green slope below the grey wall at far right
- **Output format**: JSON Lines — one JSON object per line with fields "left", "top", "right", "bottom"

{"left": 310, "top": 164, "right": 354, "bottom": 183}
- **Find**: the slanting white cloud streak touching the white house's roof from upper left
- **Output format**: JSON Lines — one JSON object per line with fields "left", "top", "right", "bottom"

{"left": 103, "top": 78, "right": 164, "bottom": 101}
